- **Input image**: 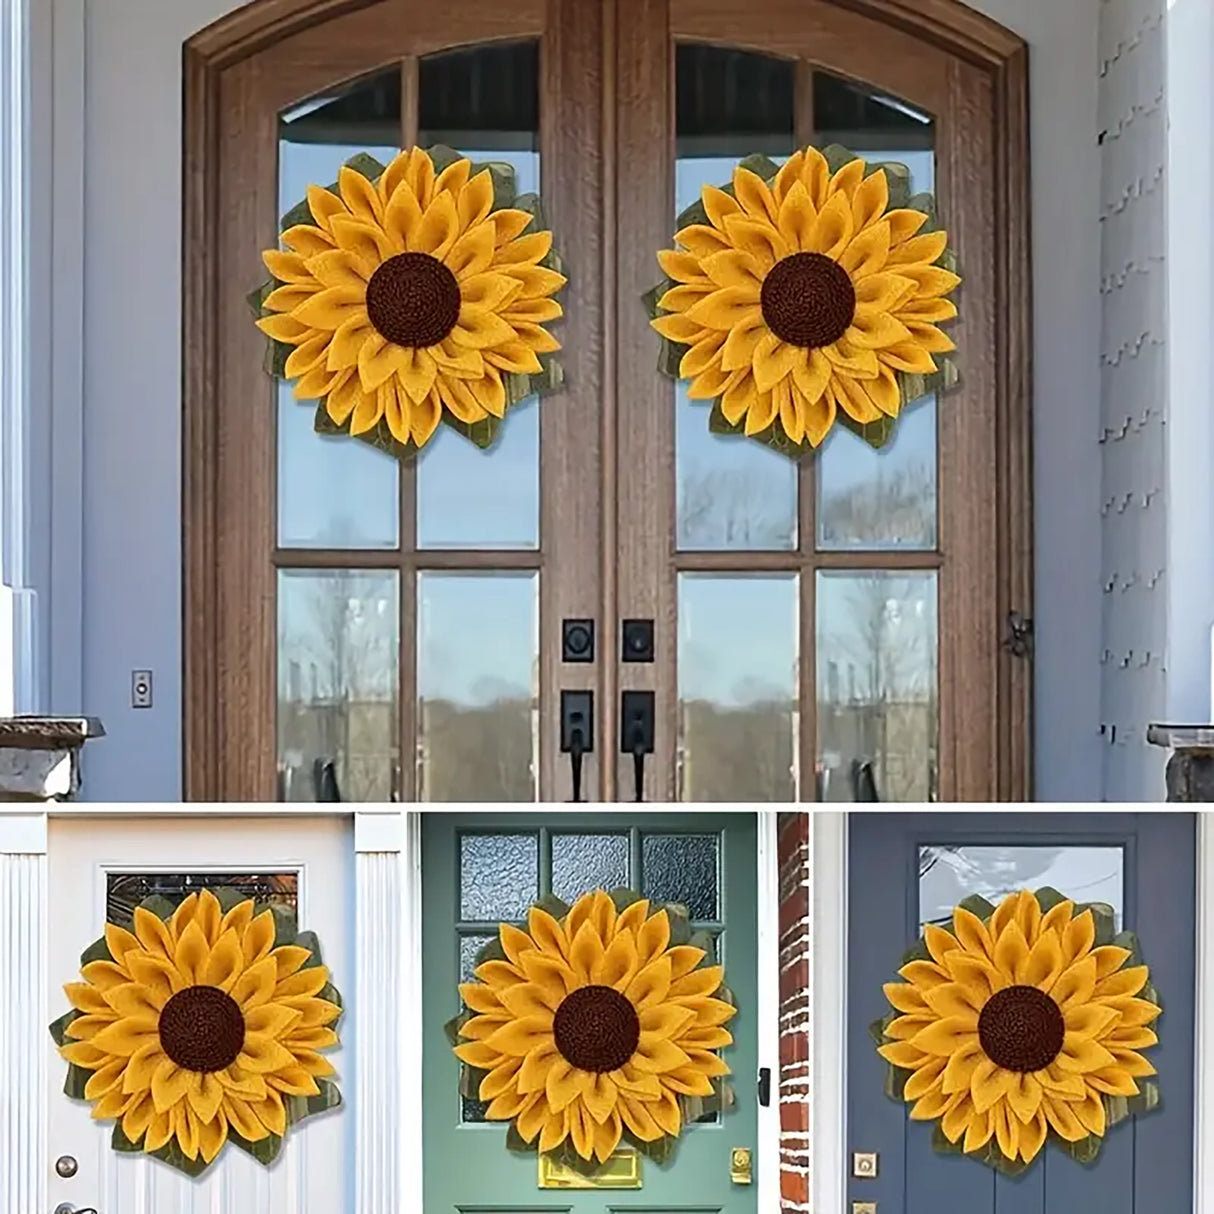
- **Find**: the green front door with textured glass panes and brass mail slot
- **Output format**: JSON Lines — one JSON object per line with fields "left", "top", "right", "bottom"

{"left": 422, "top": 813, "right": 752, "bottom": 1214}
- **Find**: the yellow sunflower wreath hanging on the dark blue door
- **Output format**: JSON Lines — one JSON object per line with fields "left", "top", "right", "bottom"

{"left": 870, "top": 889, "right": 1162, "bottom": 1175}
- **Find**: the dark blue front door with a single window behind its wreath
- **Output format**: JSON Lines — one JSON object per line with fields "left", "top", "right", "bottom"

{"left": 847, "top": 811, "right": 1196, "bottom": 1214}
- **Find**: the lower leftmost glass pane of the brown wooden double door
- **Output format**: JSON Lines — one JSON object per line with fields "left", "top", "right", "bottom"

{"left": 278, "top": 569, "right": 398, "bottom": 801}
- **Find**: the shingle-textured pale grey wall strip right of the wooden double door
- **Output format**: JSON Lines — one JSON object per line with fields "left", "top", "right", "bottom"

{"left": 1099, "top": 0, "right": 1165, "bottom": 801}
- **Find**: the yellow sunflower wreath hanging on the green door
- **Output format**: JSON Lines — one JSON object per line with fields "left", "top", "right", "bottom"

{"left": 446, "top": 889, "right": 737, "bottom": 1174}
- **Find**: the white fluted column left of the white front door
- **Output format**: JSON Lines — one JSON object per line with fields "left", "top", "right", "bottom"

{"left": 0, "top": 812, "right": 55, "bottom": 1214}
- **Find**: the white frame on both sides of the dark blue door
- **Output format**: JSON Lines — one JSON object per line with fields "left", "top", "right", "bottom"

{"left": 810, "top": 805, "right": 1214, "bottom": 1214}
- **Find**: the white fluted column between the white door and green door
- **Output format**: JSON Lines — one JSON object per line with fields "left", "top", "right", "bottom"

{"left": 353, "top": 811, "right": 422, "bottom": 1214}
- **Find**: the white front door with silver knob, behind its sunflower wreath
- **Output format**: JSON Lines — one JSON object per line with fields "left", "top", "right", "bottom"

{"left": 47, "top": 817, "right": 354, "bottom": 1214}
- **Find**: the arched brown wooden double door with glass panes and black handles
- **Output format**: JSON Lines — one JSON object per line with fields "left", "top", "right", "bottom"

{"left": 183, "top": 0, "right": 1031, "bottom": 802}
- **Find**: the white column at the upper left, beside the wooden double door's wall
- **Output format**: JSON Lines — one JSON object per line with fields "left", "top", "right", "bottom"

{"left": 0, "top": 0, "right": 38, "bottom": 716}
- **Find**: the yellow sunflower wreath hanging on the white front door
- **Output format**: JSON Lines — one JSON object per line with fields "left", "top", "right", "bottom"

{"left": 51, "top": 887, "right": 342, "bottom": 1176}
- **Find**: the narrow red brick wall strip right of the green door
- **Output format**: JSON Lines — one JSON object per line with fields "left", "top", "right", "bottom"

{"left": 778, "top": 813, "right": 810, "bottom": 1214}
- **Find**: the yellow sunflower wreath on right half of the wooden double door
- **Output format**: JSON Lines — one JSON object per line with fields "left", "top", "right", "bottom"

{"left": 645, "top": 144, "right": 960, "bottom": 456}
